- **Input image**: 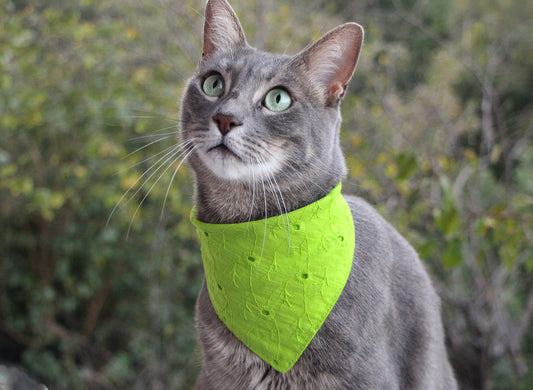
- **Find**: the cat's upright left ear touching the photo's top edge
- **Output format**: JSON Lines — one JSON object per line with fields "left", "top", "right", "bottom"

{"left": 202, "top": 0, "right": 246, "bottom": 58}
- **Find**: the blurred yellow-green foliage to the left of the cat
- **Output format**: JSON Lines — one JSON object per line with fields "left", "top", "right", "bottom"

{"left": 0, "top": 1, "right": 201, "bottom": 389}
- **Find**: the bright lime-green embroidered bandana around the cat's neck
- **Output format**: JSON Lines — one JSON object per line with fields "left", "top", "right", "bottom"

{"left": 191, "top": 184, "right": 355, "bottom": 372}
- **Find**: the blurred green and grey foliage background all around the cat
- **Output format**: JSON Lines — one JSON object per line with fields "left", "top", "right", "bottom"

{"left": 0, "top": 0, "right": 533, "bottom": 390}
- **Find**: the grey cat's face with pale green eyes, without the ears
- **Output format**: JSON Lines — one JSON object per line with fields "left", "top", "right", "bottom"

{"left": 182, "top": 48, "right": 338, "bottom": 181}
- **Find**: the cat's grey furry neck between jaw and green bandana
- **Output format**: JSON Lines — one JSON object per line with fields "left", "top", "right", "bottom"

{"left": 190, "top": 119, "right": 347, "bottom": 223}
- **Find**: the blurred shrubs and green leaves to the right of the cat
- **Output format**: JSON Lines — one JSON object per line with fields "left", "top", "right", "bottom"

{"left": 336, "top": 1, "right": 533, "bottom": 388}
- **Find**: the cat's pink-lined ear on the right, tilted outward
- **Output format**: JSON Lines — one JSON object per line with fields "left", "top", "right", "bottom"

{"left": 297, "top": 23, "right": 364, "bottom": 104}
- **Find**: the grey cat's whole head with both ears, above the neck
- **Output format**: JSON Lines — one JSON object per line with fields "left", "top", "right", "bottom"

{"left": 181, "top": 0, "right": 363, "bottom": 219}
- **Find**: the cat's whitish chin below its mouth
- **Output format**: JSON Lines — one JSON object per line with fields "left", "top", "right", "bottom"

{"left": 199, "top": 145, "right": 281, "bottom": 183}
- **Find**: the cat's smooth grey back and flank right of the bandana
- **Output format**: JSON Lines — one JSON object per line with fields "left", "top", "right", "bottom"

{"left": 331, "top": 195, "right": 457, "bottom": 389}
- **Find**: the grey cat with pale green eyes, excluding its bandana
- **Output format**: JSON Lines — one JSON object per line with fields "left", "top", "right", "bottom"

{"left": 181, "top": 0, "right": 457, "bottom": 390}
